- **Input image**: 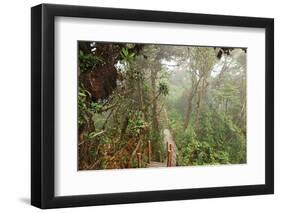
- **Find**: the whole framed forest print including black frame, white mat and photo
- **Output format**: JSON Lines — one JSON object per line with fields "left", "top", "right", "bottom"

{"left": 31, "top": 4, "right": 274, "bottom": 208}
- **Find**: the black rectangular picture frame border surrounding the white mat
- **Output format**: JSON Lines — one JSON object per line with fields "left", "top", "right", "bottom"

{"left": 31, "top": 4, "right": 274, "bottom": 209}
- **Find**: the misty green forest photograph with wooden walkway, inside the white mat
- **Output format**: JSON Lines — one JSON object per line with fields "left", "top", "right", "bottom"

{"left": 77, "top": 41, "right": 247, "bottom": 170}
